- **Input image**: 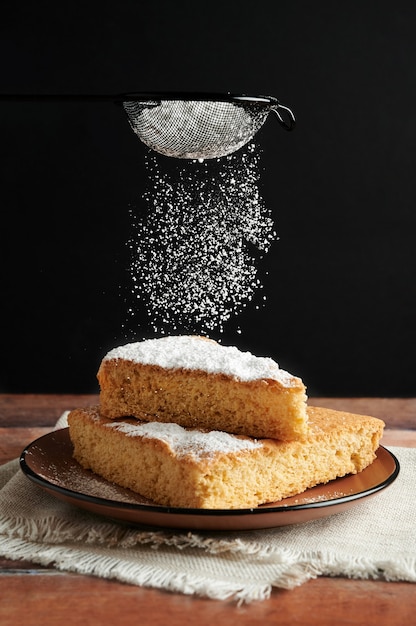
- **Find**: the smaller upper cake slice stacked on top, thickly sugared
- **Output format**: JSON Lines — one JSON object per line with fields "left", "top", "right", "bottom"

{"left": 97, "top": 336, "right": 308, "bottom": 441}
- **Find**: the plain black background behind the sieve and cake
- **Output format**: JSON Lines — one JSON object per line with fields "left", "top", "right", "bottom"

{"left": 0, "top": 0, "right": 416, "bottom": 396}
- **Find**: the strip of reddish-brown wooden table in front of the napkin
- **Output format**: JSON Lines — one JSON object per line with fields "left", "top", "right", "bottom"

{"left": 0, "top": 572, "right": 416, "bottom": 626}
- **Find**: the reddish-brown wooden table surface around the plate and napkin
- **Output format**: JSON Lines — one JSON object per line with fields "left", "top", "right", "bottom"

{"left": 0, "top": 394, "right": 416, "bottom": 626}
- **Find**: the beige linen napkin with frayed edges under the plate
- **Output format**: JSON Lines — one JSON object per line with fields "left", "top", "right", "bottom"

{"left": 0, "top": 419, "right": 416, "bottom": 602}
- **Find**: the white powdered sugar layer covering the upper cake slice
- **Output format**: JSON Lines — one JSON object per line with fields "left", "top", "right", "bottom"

{"left": 104, "top": 335, "right": 300, "bottom": 387}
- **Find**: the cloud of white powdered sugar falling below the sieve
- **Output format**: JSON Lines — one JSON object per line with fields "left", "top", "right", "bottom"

{"left": 128, "top": 144, "right": 276, "bottom": 334}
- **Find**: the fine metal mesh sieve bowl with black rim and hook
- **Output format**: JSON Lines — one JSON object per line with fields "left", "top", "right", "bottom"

{"left": 123, "top": 93, "right": 295, "bottom": 160}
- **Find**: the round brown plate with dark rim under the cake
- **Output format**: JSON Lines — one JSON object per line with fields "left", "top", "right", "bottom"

{"left": 20, "top": 428, "right": 400, "bottom": 530}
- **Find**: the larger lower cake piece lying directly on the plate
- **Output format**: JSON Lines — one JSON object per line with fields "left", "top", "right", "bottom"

{"left": 68, "top": 407, "right": 384, "bottom": 509}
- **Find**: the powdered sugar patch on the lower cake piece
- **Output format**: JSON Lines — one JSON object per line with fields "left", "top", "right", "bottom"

{"left": 106, "top": 422, "right": 262, "bottom": 460}
